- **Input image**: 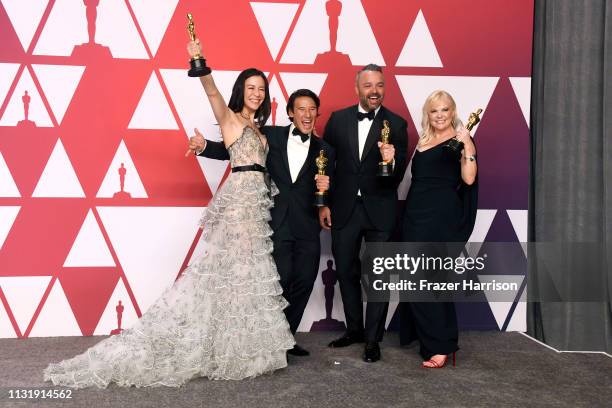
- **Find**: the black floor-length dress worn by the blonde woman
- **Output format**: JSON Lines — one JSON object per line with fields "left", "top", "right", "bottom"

{"left": 399, "top": 144, "right": 478, "bottom": 360}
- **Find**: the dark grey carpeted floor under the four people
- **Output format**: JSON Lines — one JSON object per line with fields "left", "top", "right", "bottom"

{"left": 0, "top": 332, "right": 612, "bottom": 408}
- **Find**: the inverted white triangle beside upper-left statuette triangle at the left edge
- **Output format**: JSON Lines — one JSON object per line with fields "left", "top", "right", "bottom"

{"left": 32, "top": 64, "right": 85, "bottom": 124}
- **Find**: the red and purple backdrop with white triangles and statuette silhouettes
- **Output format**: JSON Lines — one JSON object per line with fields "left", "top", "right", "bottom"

{"left": 0, "top": 0, "right": 533, "bottom": 338}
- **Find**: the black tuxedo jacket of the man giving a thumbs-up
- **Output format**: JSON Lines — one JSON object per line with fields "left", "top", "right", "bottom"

{"left": 200, "top": 126, "right": 334, "bottom": 241}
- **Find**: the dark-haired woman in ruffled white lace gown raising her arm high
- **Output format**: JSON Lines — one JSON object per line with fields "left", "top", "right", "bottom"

{"left": 44, "top": 42, "right": 295, "bottom": 388}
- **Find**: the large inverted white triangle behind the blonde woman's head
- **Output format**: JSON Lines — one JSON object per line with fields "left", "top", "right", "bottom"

{"left": 396, "top": 75, "right": 499, "bottom": 136}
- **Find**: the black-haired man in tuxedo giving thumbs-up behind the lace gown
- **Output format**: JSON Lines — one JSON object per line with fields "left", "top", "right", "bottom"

{"left": 190, "top": 89, "right": 334, "bottom": 356}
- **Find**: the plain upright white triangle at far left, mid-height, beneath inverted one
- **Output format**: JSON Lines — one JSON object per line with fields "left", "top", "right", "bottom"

{"left": 32, "top": 139, "right": 85, "bottom": 197}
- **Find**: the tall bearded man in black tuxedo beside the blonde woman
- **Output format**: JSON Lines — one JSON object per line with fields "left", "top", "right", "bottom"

{"left": 319, "top": 64, "right": 408, "bottom": 362}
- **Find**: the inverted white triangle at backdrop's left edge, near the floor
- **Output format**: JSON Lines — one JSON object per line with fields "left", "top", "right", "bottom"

{"left": 0, "top": 276, "right": 51, "bottom": 334}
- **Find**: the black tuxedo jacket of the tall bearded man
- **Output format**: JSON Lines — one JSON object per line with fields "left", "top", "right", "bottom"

{"left": 324, "top": 105, "right": 408, "bottom": 231}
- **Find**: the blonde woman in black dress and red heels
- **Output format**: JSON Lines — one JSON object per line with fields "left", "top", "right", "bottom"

{"left": 400, "top": 91, "right": 478, "bottom": 368}
